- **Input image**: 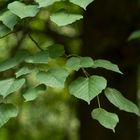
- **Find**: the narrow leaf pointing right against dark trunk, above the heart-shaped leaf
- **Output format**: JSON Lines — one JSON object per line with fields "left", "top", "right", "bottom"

{"left": 93, "top": 59, "right": 123, "bottom": 74}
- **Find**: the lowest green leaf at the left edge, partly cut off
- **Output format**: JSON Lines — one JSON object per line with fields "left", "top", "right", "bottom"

{"left": 0, "top": 103, "right": 18, "bottom": 127}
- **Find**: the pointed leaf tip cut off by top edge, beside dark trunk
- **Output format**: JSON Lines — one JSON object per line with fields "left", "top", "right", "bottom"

{"left": 70, "top": 0, "right": 94, "bottom": 10}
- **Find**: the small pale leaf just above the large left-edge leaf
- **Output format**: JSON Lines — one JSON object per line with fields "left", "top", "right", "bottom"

{"left": 15, "top": 67, "right": 32, "bottom": 78}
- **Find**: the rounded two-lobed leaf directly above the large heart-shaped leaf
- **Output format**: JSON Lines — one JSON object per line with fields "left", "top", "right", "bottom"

{"left": 66, "top": 57, "right": 94, "bottom": 71}
